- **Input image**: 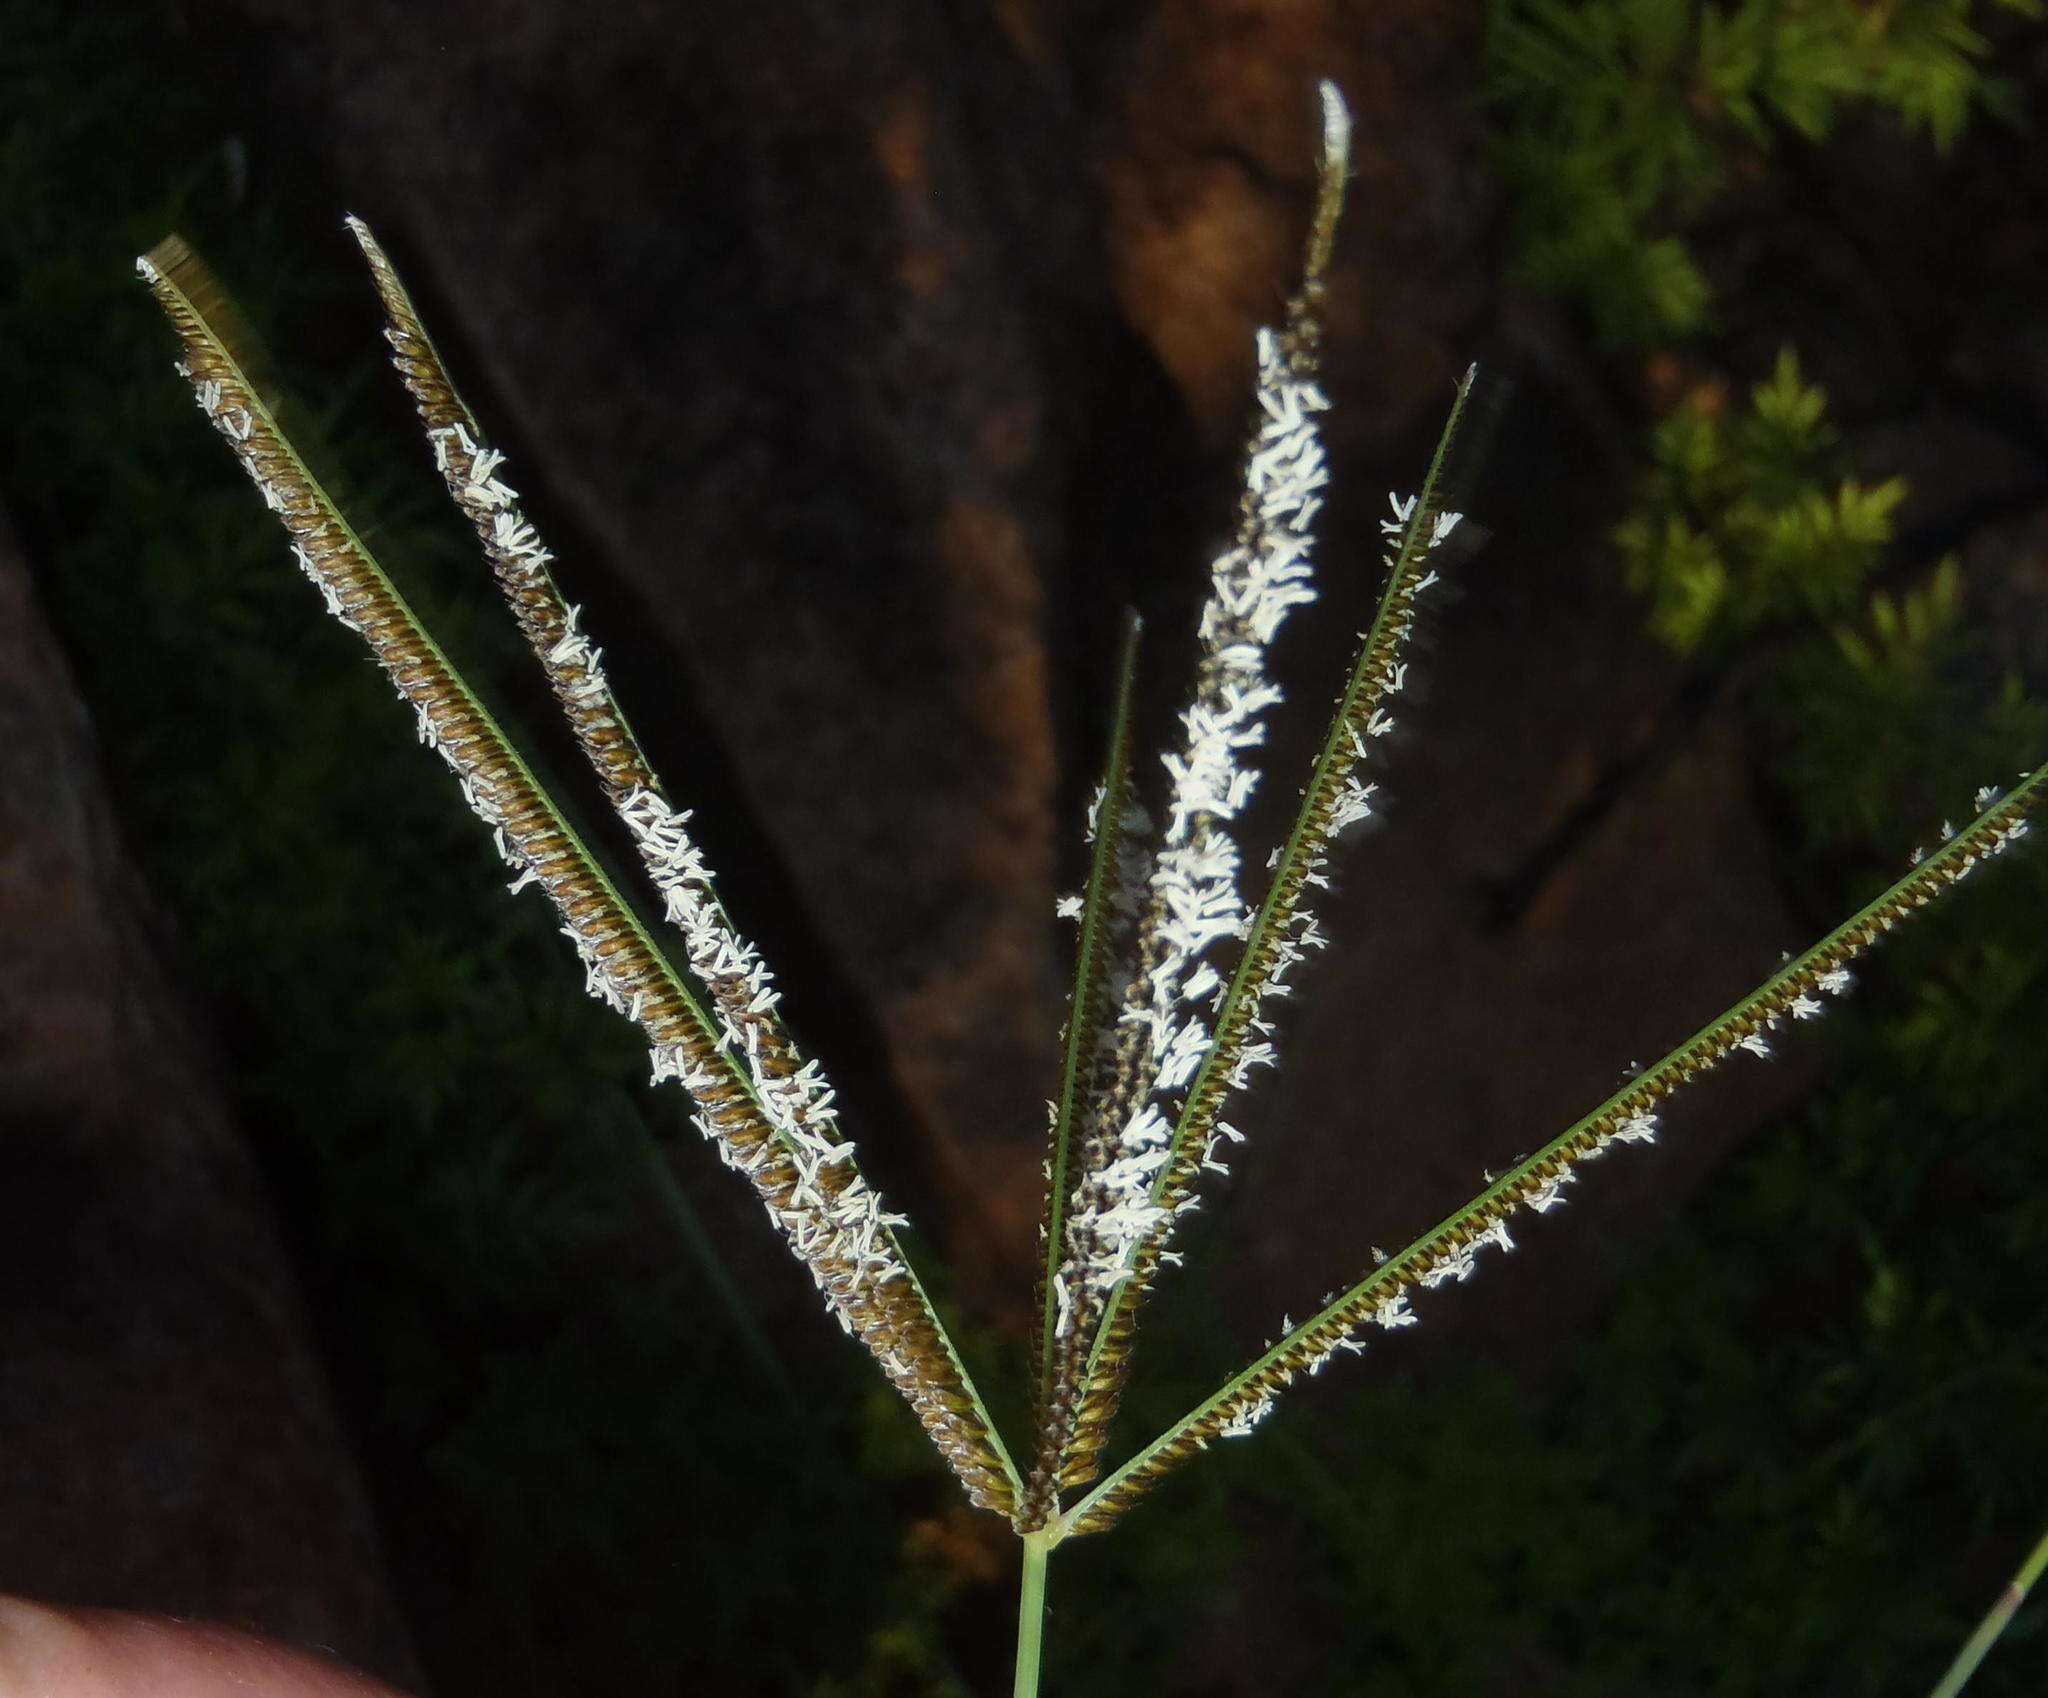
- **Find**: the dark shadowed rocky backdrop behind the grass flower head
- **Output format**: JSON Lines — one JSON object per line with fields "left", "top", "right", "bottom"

{"left": 0, "top": 0, "right": 2048, "bottom": 1698}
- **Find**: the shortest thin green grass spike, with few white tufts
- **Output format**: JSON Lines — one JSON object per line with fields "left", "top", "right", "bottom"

{"left": 1020, "top": 614, "right": 1143, "bottom": 1532}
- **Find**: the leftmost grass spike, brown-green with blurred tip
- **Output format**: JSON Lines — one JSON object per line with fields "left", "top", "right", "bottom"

{"left": 137, "top": 238, "right": 1018, "bottom": 1512}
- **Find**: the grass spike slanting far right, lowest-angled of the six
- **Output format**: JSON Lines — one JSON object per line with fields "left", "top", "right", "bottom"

{"left": 1049, "top": 766, "right": 2048, "bottom": 1538}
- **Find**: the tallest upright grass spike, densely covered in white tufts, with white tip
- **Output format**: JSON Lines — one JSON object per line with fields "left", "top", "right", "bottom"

{"left": 1032, "top": 84, "right": 1350, "bottom": 1508}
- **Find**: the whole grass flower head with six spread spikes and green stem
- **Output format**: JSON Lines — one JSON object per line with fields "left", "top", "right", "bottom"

{"left": 139, "top": 84, "right": 2048, "bottom": 1698}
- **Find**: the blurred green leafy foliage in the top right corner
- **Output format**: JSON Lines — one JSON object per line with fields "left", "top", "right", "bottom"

{"left": 1485, "top": 0, "right": 2040, "bottom": 346}
